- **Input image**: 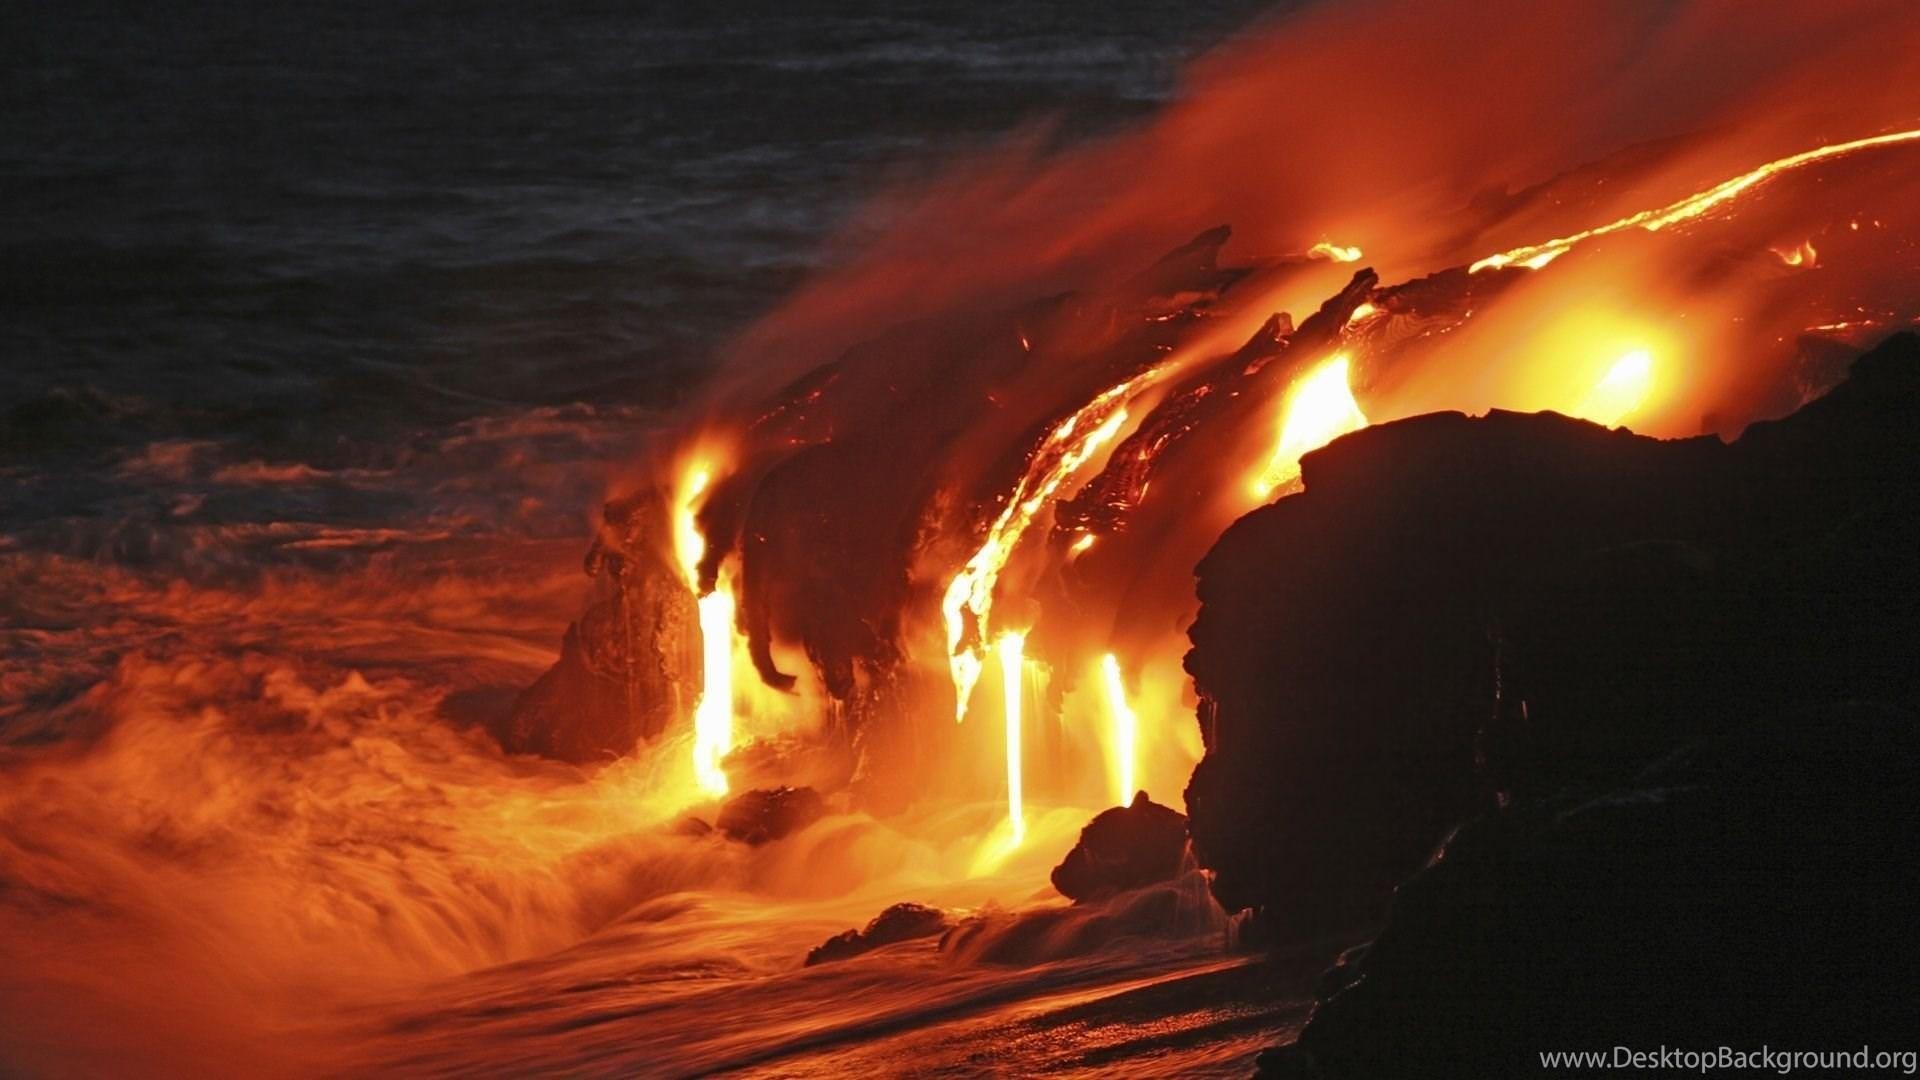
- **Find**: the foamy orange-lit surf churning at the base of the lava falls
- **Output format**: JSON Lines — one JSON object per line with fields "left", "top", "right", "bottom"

{"left": 0, "top": 544, "right": 1286, "bottom": 1076}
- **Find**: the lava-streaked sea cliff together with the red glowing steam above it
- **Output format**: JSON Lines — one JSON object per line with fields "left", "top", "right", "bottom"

{"left": 518, "top": 4, "right": 1920, "bottom": 834}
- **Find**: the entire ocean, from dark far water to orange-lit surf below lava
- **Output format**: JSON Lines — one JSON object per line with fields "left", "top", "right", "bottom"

{"left": 0, "top": 0, "right": 1300, "bottom": 1076}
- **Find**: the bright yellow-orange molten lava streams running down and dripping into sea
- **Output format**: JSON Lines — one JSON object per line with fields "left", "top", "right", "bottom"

{"left": 614, "top": 119, "right": 1920, "bottom": 822}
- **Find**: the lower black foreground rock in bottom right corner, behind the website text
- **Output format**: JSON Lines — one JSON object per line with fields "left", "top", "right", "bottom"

{"left": 1260, "top": 705, "right": 1920, "bottom": 1080}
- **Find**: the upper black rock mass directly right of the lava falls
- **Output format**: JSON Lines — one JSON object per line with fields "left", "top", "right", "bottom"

{"left": 1187, "top": 334, "right": 1920, "bottom": 934}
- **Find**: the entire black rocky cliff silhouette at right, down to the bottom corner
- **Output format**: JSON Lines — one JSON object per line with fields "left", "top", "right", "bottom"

{"left": 1187, "top": 334, "right": 1920, "bottom": 1076}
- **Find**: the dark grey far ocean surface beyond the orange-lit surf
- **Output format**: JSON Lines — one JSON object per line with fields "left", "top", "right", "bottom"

{"left": 0, "top": 0, "right": 1261, "bottom": 569}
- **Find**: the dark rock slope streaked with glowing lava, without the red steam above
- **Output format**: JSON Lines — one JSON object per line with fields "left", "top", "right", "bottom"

{"left": 595, "top": 111, "right": 1920, "bottom": 844}
